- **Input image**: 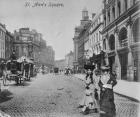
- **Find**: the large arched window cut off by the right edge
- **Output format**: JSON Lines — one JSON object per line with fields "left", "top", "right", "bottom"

{"left": 132, "top": 17, "right": 140, "bottom": 42}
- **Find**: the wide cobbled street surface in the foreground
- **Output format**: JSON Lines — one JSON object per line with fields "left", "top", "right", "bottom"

{"left": 0, "top": 74, "right": 139, "bottom": 117}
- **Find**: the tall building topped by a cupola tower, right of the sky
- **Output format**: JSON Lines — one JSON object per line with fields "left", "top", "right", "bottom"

{"left": 73, "top": 8, "right": 91, "bottom": 71}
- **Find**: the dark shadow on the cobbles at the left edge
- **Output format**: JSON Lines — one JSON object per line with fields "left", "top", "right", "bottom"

{"left": 0, "top": 90, "right": 13, "bottom": 103}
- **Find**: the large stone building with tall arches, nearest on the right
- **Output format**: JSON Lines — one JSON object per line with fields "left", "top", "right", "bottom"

{"left": 102, "top": 0, "right": 140, "bottom": 81}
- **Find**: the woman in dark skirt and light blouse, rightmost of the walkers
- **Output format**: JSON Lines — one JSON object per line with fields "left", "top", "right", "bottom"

{"left": 99, "top": 66, "right": 117, "bottom": 117}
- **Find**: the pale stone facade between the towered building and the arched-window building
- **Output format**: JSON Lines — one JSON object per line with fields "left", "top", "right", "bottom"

{"left": 87, "top": 13, "right": 103, "bottom": 57}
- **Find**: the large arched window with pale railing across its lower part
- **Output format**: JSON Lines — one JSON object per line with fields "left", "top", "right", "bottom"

{"left": 119, "top": 27, "right": 128, "bottom": 47}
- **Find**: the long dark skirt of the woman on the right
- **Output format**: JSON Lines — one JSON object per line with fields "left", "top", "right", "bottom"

{"left": 100, "top": 88, "right": 116, "bottom": 115}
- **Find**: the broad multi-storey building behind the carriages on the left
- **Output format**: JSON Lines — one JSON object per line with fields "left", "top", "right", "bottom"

{"left": 14, "top": 28, "right": 41, "bottom": 62}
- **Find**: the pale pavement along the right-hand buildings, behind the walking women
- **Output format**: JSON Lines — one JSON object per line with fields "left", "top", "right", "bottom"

{"left": 74, "top": 74, "right": 140, "bottom": 102}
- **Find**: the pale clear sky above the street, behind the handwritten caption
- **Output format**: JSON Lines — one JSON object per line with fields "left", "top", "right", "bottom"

{"left": 0, "top": 0, "right": 103, "bottom": 60}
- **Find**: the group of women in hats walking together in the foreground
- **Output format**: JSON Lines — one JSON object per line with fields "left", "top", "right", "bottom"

{"left": 78, "top": 65, "right": 117, "bottom": 117}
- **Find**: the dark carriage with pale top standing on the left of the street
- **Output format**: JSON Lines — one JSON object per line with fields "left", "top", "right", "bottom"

{"left": 5, "top": 57, "right": 33, "bottom": 84}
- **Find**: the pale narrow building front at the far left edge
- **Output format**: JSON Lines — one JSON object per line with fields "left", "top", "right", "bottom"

{"left": 0, "top": 23, "right": 6, "bottom": 60}
